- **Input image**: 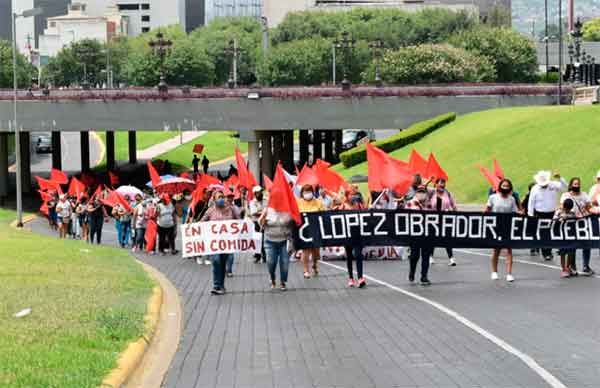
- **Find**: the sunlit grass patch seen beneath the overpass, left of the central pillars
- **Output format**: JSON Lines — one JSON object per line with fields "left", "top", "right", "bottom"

{"left": 156, "top": 131, "right": 248, "bottom": 172}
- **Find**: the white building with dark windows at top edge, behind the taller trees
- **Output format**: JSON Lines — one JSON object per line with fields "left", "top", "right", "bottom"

{"left": 81, "top": 0, "right": 186, "bottom": 36}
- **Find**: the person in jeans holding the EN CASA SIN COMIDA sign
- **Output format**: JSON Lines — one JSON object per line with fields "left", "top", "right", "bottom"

{"left": 200, "top": 190, "right": 238, "bottom": 295}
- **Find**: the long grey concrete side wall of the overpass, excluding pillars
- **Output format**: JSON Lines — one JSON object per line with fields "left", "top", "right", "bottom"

{"left": 0, "top": 95, "right": 556, "bottom": 131}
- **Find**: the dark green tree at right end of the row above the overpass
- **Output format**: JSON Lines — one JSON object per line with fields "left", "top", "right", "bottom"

{"left": 450, "top": 27, "right": 538, "bottom": 82}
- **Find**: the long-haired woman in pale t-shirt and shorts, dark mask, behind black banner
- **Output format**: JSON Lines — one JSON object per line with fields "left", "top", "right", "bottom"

{"left": 485, "top": 178, "right": 519, "bottom": 282}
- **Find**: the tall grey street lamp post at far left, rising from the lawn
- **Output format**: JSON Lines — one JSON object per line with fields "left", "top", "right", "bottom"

{"left": 12, "top": 8, "right": 44, "bottom": 228}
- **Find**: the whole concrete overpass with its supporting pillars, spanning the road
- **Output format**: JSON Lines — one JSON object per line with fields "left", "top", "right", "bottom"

{"left": 0, "top": 84, "right": 571, "bottom": 200}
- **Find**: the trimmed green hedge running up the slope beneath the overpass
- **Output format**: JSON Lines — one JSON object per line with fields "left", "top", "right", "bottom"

{"left": 340, "top": 112, "right": 456, "bottom": 168}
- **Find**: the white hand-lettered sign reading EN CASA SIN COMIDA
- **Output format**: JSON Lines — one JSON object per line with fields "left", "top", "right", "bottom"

{"left": 181, "top": 220, "right": 262, "bottom": 257}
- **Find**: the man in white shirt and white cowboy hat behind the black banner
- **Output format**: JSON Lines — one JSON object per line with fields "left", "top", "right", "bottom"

{"left": 527, "top": 171, "right": 567, "bottom": 260}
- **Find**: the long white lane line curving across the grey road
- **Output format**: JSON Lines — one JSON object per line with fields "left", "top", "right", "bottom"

{"left": 321, "top": 261, "right": 567, "bottom": 388}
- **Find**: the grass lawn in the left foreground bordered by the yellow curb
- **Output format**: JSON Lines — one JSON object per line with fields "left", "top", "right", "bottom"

{"left": 0, "top": 209, "right": 153, "bottom": 388}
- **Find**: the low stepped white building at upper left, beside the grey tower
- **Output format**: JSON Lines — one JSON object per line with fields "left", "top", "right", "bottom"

{"left": 39, "top": 3, "right": 128, "bottom": 61}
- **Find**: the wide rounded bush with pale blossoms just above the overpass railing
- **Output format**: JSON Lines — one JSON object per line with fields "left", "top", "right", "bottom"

{"left": 363, "top": 44, "right": 495, "bottom": 84}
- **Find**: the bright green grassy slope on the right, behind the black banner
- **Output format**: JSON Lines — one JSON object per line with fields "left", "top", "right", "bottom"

{"left": 335, "top": 105, "right": 600, "bottom": 203}
